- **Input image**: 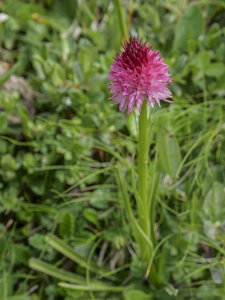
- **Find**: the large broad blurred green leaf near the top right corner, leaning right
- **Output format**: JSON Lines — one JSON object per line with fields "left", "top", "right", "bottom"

{"left": 174, "top": 5, "right": 204, "bottom": 51}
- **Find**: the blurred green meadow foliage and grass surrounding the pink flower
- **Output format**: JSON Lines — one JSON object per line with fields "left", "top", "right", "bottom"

{"left": 0, "top": 0, "right": 225, "bottom": 300}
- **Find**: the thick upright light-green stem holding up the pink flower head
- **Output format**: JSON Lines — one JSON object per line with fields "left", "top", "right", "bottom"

{"left": 137, "top": 101, "right": 160, "bottom": 286}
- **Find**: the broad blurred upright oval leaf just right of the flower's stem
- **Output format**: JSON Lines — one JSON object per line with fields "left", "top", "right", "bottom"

{"left": 157, "top": 128, "right": 181, "bottom": 178}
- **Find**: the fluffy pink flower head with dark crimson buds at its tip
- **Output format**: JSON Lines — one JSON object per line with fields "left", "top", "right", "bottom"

{"left": 109, "top": 37, "right": 172, "bottom": 114}
